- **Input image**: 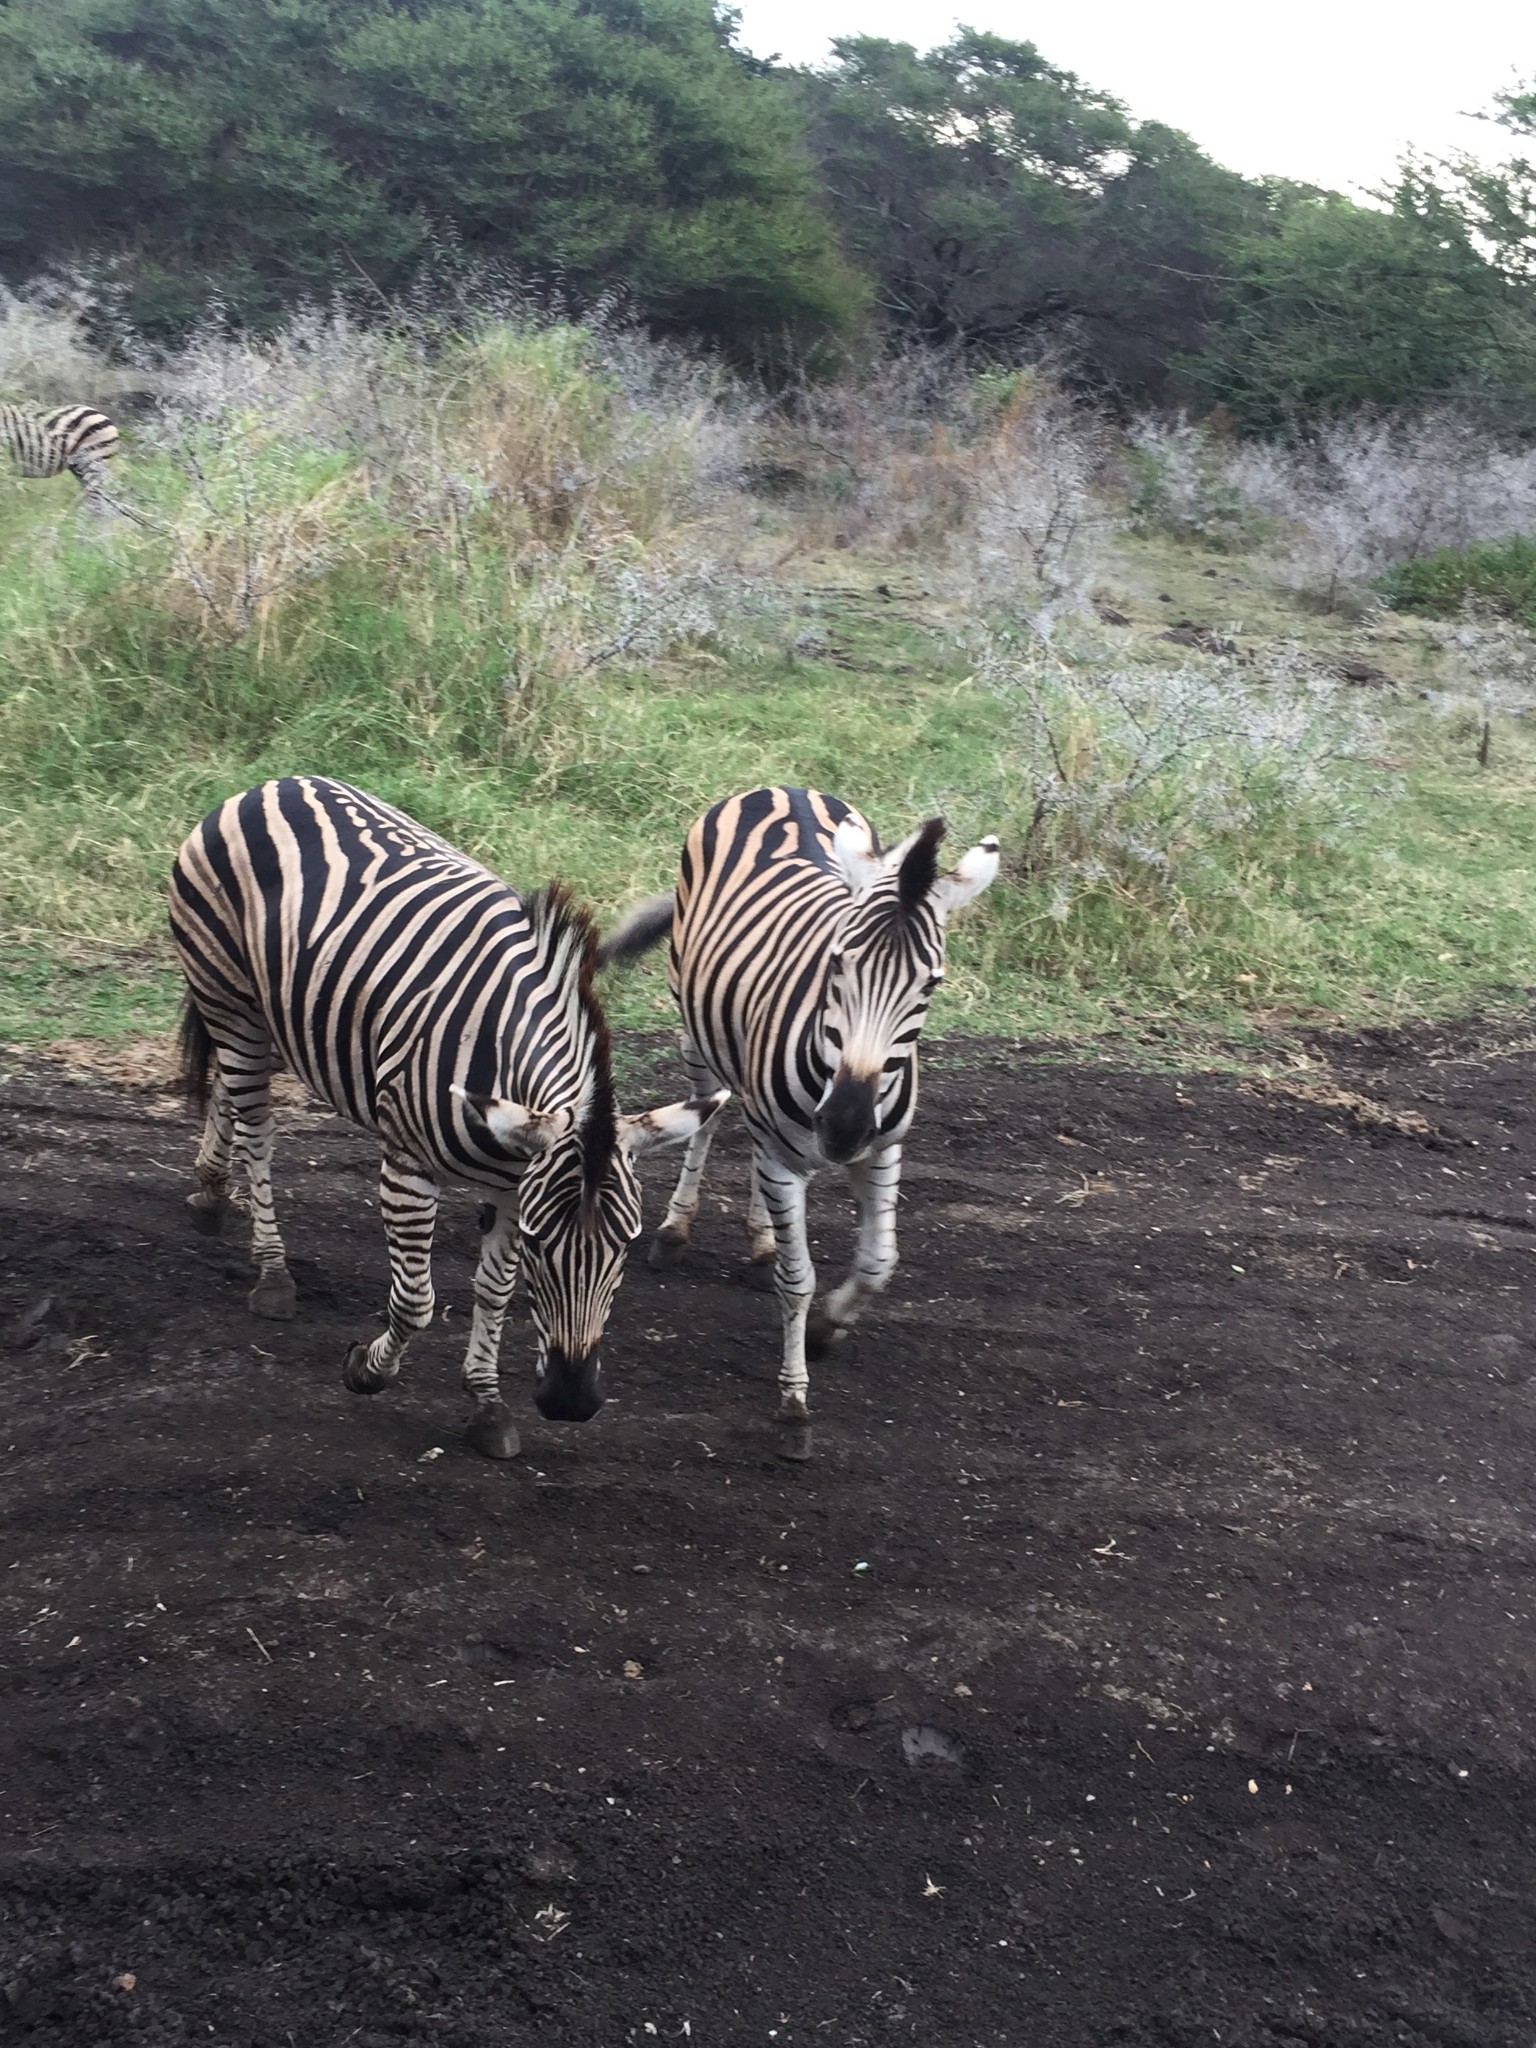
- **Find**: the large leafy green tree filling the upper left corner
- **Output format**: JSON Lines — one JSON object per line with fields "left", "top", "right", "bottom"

{"left": 0, "top": 0, "right": 862, "bottom": 352}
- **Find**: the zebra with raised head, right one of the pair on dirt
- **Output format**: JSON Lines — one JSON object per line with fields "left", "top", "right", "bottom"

{"left": 598, "top": 788, "right": 997, "bottom": 1458}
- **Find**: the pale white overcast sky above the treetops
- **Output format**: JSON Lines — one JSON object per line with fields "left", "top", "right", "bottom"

{"left": 735, "top": 0, "right": 1536, "bottom": 197}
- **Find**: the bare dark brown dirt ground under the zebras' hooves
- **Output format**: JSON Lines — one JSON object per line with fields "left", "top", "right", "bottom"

{"left": 0, "top": 1038, "right": 1536, "bottom": 2048}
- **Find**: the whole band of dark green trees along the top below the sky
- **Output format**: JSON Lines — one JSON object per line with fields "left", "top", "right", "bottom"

{"left": 0, "top": 0, "right": 1536, "bottom": 432}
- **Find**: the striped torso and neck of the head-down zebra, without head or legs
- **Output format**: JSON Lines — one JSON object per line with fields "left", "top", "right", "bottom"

{"left": 172, "top": 776, "right": 614, "bottom": 1186}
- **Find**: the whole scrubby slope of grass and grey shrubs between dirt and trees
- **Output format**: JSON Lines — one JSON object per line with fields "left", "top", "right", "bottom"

{"left": 0, "top": 301, "right": 1536, "bottom": 1044}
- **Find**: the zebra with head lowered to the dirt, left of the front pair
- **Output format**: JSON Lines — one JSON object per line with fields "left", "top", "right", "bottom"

{"left": 170, "top": 776, "right": 727, "bottom": 1458}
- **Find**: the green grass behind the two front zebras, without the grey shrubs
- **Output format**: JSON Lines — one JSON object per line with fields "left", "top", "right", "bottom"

{"left": 0, "top": 485, "right": 1536, "bottom": 1042}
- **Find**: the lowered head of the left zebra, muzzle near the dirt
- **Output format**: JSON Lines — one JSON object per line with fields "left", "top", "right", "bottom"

{"left": 463, "top": 1089, "right": 731, "bottom": 1421}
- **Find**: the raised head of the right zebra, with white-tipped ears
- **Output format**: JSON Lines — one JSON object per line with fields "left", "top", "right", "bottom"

{"left": 813, "top": 817, "right": 1011, "bottom": 1165}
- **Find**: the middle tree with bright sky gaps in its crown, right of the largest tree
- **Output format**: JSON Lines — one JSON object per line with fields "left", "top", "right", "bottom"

{"left": 801, "top": 29, "right": 1264, "bottom": 397}
